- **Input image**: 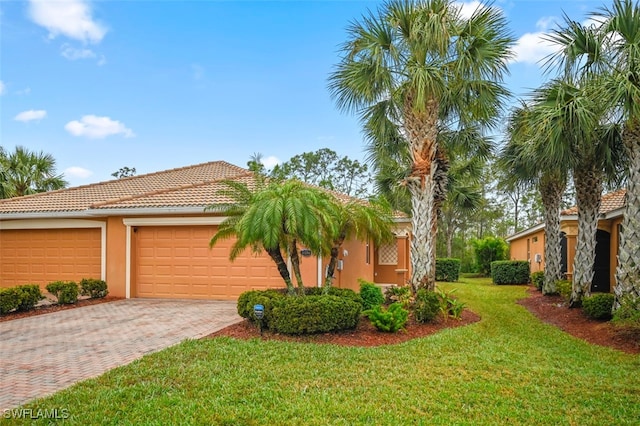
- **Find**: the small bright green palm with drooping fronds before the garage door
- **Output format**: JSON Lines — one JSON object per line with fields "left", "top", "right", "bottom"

{"left": 206, "top": 179, "right": 337, "bottom": 294}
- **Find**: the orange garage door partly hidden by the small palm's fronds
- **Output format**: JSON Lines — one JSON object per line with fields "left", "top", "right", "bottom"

{"left": 132, "top": 226, "right": 282, "bottom": 299}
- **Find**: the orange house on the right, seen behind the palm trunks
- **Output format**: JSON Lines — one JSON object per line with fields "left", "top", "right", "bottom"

{"left": 507, "top": 189, "right": 625, "bottom": 292}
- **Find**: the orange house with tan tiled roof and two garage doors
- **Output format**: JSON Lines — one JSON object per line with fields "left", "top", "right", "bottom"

{"left": 0, "top": 161, "right": 410, "bottom": 299}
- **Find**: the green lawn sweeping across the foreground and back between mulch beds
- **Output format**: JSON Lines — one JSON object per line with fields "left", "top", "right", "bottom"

{"left": 6, "top": 279, "right": 640, "bottom": 425}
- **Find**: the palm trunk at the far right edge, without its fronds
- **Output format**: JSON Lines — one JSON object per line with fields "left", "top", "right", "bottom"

{"left": 614, "top": 121, "right": 640, "bottom": 309}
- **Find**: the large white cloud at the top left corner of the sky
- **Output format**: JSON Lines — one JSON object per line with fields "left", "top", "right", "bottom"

{"left": 29, "top": 0, "right": 107, "bottom": 43}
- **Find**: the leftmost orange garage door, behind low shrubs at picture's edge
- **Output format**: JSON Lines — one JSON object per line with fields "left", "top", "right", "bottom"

{"left": 0, "top": 228, "right": 101, "bottom": 287}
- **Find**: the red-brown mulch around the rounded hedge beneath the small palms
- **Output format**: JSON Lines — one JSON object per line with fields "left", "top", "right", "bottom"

{"left": 206, "top": 309, "right": 480, "bottom": 347}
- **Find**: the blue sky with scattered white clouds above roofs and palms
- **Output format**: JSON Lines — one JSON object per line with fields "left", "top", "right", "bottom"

{"left": 0, "top": 0, "right": 608, "bottom": 186}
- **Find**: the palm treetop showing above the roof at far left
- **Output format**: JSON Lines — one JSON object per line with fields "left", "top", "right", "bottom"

{"left": 0, "top": 146, "right": 67, "bottom": 198}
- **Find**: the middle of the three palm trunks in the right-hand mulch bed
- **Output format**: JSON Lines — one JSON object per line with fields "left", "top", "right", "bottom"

{"left": 569, "top": 162, "right": 602, "bottom": 307}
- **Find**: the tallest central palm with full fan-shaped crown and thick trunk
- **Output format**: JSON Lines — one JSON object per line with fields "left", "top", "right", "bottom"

{"left": 329, "top": 0, "right": 513, "bottom": 290}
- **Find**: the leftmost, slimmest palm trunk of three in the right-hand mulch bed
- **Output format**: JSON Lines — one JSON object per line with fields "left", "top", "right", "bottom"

{"left": 540, "top": 175, "right": 566, "bottom": 295}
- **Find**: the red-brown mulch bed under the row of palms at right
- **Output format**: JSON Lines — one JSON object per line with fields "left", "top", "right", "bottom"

{"left": 518, "top": 287, "right": 640, "bottom": 354}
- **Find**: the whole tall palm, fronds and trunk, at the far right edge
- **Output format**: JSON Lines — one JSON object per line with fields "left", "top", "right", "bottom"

{"left": 594, "top": 0, "right": 640, "bottom": 307}
